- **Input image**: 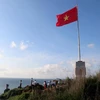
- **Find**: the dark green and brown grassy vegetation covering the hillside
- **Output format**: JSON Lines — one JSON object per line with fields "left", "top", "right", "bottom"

{"left": 0, "top": 73, "right": 100, "bottom": 100}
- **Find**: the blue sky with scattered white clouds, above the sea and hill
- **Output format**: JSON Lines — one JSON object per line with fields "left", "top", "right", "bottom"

{"left": 0, "top": 0, "right": 100, "bottom": 78}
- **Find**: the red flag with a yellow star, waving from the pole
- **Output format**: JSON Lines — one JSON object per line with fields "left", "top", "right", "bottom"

{"left": 56, "top": 7, "right": 78, "bottom": 26}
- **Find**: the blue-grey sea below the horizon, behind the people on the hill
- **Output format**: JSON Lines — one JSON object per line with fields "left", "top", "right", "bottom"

{"left": 0, "top": 78, "right": 53, "bottom": 94}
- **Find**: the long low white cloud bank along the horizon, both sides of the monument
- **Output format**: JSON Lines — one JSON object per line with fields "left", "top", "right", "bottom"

{"left": 0, "top": 61, "right": 99, "bottom": 79}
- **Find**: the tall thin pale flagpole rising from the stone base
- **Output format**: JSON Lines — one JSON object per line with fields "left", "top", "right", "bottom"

{"left": 76, "top": 0, "right": 81, "bottom": 61}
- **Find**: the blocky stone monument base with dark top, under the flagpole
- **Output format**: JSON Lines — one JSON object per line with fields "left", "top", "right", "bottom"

{"left": 75, "top": 61, "right": 86, "bottom": 79}
